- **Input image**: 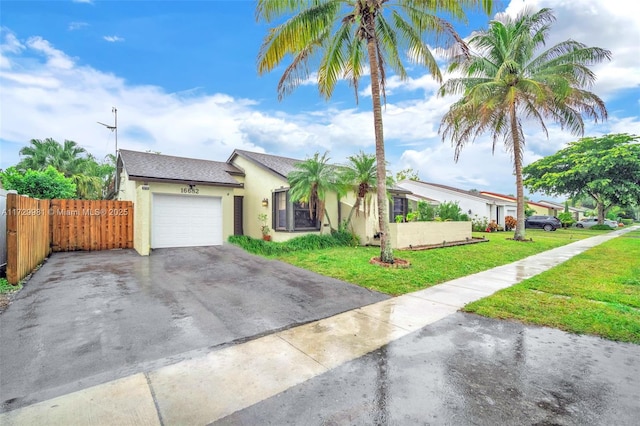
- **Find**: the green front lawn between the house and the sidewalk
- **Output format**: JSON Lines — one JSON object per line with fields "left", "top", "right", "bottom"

{"left": 275, "top": 228, "right": 610, "bottom": 296}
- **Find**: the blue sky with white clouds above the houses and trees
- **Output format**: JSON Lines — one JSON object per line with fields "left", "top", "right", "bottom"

{"left": 0, "top": 0, "right": 640, "bottom": 199}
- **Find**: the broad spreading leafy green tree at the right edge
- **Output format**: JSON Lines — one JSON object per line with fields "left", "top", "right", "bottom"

{"left": 523, "top": 133, "right": 640, "bottom": 224}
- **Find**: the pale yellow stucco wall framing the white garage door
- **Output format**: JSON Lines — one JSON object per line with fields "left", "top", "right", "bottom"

{"left": 120, "top": 175, "right": 235, "bottom": 256}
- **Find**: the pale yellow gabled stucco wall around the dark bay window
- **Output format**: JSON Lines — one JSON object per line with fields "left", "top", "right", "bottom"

{"left": 232, "top": 156, "right": 338, "bottom": 242}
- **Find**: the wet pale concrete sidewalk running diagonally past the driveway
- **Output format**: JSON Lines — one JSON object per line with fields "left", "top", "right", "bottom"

{"left": 0, "top": 227, "right": 637, "bottom": 425}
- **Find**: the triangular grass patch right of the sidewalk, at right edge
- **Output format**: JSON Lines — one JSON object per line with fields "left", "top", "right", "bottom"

{"left": 464, "top": 231, "right": 640, "bottom": 344}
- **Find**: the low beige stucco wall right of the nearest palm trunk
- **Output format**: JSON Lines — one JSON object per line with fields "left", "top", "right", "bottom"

{"left": 389, "top": 222, "right": 471, "bottom": 249}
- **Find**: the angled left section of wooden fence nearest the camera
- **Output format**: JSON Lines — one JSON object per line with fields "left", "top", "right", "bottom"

{"left": 6, "top": 194, "right": 51, "bottom": 284}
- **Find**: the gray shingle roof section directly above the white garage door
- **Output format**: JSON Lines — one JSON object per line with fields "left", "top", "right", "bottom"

{"left": 120, "top": 149, "right": 243, "bottom": 186}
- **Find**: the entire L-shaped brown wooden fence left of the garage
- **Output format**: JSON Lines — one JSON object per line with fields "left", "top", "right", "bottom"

{"left": 6, "top": 194, "right": 133, "bottom": 284}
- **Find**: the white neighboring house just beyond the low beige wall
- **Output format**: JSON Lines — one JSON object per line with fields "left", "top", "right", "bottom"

{"left": 398, "top": 180, "right": 516, "bottom": 226}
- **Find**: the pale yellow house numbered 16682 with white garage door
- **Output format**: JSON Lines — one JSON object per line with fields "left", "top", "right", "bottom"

{"left": 117, "top": 150, "right": 418, "bottom": 255}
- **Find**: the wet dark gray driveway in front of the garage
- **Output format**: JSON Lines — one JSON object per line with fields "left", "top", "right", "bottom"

{"left": 0, "top": 245, "right": 388, "bottom": 411}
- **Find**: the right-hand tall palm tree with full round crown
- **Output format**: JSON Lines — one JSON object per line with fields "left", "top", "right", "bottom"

{"left": 440, "top": 9, "right": 611, "bottom": 240}
